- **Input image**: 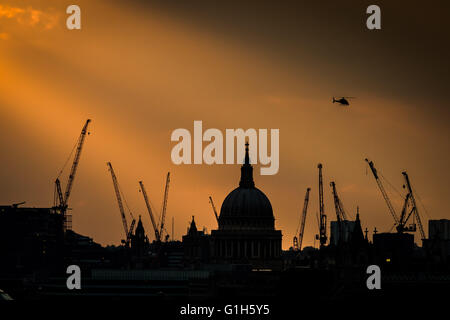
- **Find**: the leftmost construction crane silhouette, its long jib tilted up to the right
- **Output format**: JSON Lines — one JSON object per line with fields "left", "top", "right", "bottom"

{"left": 55, "top": 119, "right": 91, "bottom": 230}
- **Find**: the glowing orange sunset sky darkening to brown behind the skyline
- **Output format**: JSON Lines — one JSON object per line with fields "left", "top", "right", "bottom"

{"left": 0, "top": 0, "right": 450, "bottom": 249}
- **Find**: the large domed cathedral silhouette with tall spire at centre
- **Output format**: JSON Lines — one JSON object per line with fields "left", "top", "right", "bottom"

{"left": 211, "top": 143, "right": 282, "bottom": 269}
